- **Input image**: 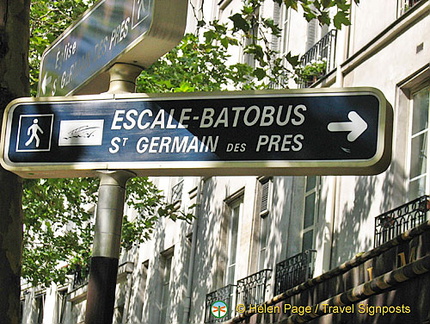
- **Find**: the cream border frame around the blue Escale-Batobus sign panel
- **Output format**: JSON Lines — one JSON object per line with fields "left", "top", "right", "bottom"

{"left": 0, "top": 87, "right": 393, "bottom": 178}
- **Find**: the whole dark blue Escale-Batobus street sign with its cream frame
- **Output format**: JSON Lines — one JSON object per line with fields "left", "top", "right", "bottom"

{"left": 1, "top": 88, "right": 392, "bottom": 178}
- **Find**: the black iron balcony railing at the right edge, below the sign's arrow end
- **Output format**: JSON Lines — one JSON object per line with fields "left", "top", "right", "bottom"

{"left": 374, "top": 196, "right": 430, "bottom": 247}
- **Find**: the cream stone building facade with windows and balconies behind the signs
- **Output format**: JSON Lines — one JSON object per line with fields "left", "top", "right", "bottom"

{"left": 23, "top": 0, "right": 430, "bottom": 324}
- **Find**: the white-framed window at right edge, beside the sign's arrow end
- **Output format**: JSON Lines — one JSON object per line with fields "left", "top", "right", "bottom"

{"left": 408, "top": 86, "right": 430, "bottom": 200}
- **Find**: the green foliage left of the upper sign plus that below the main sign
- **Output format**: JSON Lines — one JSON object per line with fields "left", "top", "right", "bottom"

{"left": 22, "top": 0, "right": 190, "bottom": 286}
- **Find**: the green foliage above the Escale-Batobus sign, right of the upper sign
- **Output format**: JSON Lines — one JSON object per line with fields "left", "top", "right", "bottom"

{"left": 138, "top": 0, "right": 359, "bottom": 92}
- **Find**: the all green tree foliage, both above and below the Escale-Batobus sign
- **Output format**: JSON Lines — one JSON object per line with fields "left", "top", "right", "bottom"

{"left": 23, "top": 0, "right": 359, "bottom": 285}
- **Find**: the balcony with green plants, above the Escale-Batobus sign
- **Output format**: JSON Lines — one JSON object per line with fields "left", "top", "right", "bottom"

{"left": 296, "top": 29, "right": 337, "bottom": 88}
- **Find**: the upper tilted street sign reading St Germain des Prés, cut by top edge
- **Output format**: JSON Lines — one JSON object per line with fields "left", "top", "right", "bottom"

{"left": 38, "top": 0, "right": 188, "bottom": 97}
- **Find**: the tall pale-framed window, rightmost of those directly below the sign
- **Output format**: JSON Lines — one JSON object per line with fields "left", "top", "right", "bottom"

{"left": 302, "top": 176, "right": 319, "bottom": 252}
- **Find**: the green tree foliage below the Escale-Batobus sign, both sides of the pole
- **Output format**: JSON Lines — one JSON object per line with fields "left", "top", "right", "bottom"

{"left": 22, "top": 178, "right": 181, "bottom": 285}
